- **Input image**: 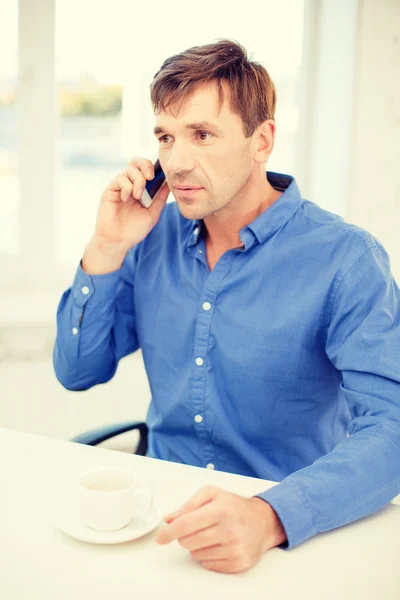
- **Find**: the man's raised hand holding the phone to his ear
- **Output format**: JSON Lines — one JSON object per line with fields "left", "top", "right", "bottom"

{"left": 82, "top": 158, "right": 169, "bottom": 275}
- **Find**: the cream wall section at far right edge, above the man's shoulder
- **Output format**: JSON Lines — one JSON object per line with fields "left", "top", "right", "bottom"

{"left": 345, "top": 0, "right": 400, "bottom": 284}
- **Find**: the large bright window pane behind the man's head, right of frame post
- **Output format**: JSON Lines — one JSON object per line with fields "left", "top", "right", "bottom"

{"left": 56, "top": 0, "right": 304, "bottom": 264}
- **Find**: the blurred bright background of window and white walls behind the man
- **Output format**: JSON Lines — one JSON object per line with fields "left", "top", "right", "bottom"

{"left": 0, "top": 0, "right": 400, "bottom": 445}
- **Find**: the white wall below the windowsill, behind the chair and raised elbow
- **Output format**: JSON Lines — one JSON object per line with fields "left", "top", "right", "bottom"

{"left": 0, "top": 352, "right": 150, "bottom": 451}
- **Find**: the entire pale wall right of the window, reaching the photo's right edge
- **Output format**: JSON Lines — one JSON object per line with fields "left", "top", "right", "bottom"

{"left": 297, "top": 0, "right": 400, "bottom": 282}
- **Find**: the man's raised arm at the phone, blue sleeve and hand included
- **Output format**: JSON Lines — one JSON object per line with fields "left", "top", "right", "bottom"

{"left": 53, "top": 158, "right": 169, "bottom": 390}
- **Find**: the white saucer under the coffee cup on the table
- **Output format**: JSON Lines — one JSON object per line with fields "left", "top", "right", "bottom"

{"left": 55, "top": 508, "right": 162, "bottom": 544}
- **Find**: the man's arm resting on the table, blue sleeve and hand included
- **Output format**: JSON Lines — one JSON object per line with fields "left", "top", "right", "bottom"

{"left": 157, "top": 246, "right": 400, "bottom": 573}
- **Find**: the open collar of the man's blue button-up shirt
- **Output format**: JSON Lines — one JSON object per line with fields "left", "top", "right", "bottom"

{"left": 187, "top": 171, "right": 303, "bottom": 249}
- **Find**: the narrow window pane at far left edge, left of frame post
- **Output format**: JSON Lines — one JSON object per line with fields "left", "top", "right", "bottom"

{"left": 0, "top": 0, "right": 19, "bottom": 254}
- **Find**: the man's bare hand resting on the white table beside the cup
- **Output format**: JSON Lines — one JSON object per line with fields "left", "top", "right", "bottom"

{"left": 157, "top": 486, "right": 286, "bottom": 573}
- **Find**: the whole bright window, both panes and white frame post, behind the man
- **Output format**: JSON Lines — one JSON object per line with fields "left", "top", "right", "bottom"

{"left": 0, "top": 0, "right": 304, "bottom": 282}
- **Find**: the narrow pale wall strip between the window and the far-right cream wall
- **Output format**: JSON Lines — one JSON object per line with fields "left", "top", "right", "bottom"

{"left": 297, "top": 0, "right": 360, "bottom": 216}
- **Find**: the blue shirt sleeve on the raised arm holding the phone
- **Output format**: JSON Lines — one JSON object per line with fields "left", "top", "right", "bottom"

{"left": 53, "top": 247, "right": 139, "bottom": 390}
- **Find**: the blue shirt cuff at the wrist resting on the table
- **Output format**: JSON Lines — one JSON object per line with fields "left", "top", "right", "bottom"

{"left": 256, "top": 480, "right": 317, "bottom": 549}
